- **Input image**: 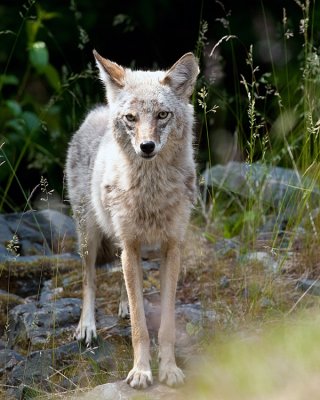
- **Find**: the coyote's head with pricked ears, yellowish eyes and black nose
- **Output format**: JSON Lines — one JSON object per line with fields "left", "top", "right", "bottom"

{"left": 94, "top": 51, "right": 199, "bottom": 159}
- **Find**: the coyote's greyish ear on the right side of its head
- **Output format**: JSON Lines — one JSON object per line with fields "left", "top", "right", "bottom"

{"left": 161, "top": 53, "right": 199, "bottom": 98}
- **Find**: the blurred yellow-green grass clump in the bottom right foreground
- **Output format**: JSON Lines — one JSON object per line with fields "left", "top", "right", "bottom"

{"left": 186, "top": 315, "right": 320, "bottom": 400}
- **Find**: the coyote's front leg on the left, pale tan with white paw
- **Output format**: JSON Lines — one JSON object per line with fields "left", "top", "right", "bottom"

{"left": 122, "top": 243, "right": 152, "bottom": 389}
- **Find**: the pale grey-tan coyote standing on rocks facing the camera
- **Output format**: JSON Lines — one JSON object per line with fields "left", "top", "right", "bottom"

{"left": 66, "top": 51, "right": 199, "bottom": 389}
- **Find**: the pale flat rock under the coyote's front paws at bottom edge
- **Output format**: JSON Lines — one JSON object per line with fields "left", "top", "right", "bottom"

{"left": 75, "top": 381, "right": 182, "bottom": 400}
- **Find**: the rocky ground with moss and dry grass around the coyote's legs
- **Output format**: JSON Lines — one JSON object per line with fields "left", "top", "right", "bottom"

{"left": 0, "top": 163, "right": 320, "bottom": 399}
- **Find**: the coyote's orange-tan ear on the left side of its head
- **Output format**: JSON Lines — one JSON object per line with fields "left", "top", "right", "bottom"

{"left": 93, "top": 50, "right": 125, "bottom": 99}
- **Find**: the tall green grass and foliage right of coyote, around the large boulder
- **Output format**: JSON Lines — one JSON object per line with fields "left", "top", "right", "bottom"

{"left": 197, "top": 0, "right": 320, "bottom": 247}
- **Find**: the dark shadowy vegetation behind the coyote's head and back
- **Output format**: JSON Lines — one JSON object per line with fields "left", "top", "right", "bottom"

{"left": 0, "top": 0, "right": 320, "bottom": 212}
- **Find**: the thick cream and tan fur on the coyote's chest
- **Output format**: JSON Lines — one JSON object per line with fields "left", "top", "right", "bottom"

{"left": 100, "top": 150, "right": 191, "bottom": 243}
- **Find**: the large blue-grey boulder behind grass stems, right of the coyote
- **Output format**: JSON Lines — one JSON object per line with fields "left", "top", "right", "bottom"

{"left": 203, "top": 161, "right": 320, "bottom": 217}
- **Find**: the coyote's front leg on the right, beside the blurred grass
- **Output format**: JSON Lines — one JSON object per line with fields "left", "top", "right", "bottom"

{"left": 159, "top": 241, "right": 184, "bottom": 386}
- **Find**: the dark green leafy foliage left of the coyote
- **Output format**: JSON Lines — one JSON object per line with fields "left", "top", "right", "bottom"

{"left": 0, "top": 0, "right": 93, "bottom": 211}
